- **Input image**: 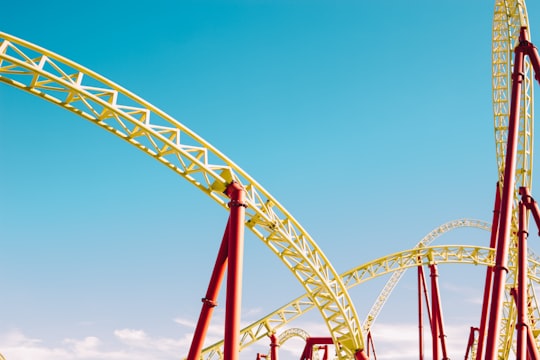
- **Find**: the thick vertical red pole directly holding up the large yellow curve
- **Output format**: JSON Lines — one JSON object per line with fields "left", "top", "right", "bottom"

{"left": 223, "top": 182, "right": 246, "bottom": 360}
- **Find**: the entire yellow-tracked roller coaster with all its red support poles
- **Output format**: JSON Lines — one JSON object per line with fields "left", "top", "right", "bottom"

{"left": 0, "top": 0, "right": 540, "bottom": 360}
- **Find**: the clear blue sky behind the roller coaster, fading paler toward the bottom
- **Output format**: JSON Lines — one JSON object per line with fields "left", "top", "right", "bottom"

{"left": 0, "top": 0, "right": 540, "bottom": 360}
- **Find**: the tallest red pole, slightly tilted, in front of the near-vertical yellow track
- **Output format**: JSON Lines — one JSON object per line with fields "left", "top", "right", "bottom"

{"left": 485, "top": 28, "right": 524, "bottom": 360}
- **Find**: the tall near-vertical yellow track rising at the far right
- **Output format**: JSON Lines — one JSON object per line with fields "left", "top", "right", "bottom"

{"left": 492, "top": 0, "right": 540, "bottom": 359}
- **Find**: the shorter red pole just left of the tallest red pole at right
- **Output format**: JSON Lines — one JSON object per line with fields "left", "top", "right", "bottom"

{"left": 476, "top": 182, "right": 501, "bottom": 360}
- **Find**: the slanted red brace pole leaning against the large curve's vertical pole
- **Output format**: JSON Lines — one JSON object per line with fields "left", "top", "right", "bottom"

{"left": 187, "top": 218, "right": 230, "bottom": 360}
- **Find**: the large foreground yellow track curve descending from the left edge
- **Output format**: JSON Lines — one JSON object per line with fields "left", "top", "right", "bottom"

{"left": 0, "top": 33, "right": 364, "bottom": 358}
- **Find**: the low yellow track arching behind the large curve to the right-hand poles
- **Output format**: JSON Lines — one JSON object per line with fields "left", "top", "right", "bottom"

{"left": 198, "top": 245, "right": 498, "bottom": 360}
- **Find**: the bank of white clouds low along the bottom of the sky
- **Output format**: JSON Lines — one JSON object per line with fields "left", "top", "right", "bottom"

{"left": 0, "top": 319, "right": 486, "bottom": 360}
